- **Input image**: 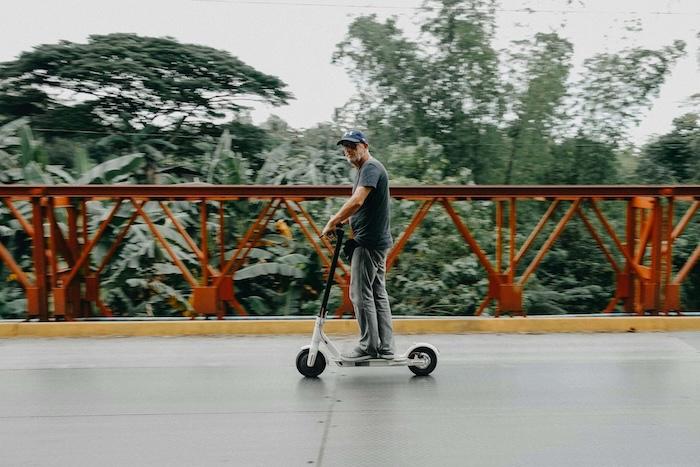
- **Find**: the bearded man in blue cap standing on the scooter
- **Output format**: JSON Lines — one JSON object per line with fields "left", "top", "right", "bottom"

{"left": 321, "top": 130, "right": 394, "bottom": 361}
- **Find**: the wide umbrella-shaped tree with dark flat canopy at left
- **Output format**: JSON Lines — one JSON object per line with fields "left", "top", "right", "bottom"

{"left": 0, "top": 33, "right": 292, "bottom": 172}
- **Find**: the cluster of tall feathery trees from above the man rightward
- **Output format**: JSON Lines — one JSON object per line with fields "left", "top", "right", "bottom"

{"left": 334, "top": 0, "right": 685, "bottom": 184}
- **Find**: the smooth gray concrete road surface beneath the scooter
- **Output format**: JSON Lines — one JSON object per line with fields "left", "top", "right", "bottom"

{"left": 0, "top": 333, "right": 700, "bottom": 467}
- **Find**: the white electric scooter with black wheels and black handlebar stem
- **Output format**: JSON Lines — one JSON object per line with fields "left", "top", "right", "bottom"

{"left": 296, "top": 228, "right": 439, "bottom": 378}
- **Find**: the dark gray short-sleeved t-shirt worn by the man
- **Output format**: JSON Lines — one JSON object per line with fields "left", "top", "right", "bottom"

{"left": 350, "top": 158, "right": 394, "bottom": 250}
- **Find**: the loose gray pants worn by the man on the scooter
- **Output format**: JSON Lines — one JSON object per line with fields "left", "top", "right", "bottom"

{"left": 350, "top": 246, "right": 394, "bottom": 354}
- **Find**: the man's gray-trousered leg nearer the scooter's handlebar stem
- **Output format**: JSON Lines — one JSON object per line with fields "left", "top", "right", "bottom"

{"left": 350, "top": 246, "right": 379, "bottom": 355}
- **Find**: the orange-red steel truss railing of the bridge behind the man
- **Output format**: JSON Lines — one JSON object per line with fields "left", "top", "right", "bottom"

{"left": 0, "top": 185, "right": 700, "bottom": 320}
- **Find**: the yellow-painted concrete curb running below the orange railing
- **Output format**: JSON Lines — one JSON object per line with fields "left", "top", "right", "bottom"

{"left": 0, "top": 316, "right": 700, "bottom": 338}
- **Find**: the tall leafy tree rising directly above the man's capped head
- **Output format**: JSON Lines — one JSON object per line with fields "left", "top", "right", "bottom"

{"left": 333, "top": 0, "right": 503, "bottom": 182}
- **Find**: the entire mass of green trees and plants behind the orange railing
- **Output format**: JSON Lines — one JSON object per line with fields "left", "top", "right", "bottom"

{"left": 0, "top": 10, "right": 700, "bottom": 318}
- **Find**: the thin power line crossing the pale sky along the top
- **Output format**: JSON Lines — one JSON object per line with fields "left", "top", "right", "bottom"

{"left": 192, "top": 0, "right": 700, "bottom": 16}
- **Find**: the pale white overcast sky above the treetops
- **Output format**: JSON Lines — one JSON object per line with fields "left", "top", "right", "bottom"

{"left": 0, "top": 0, "right": 700, "bottom": 144}
